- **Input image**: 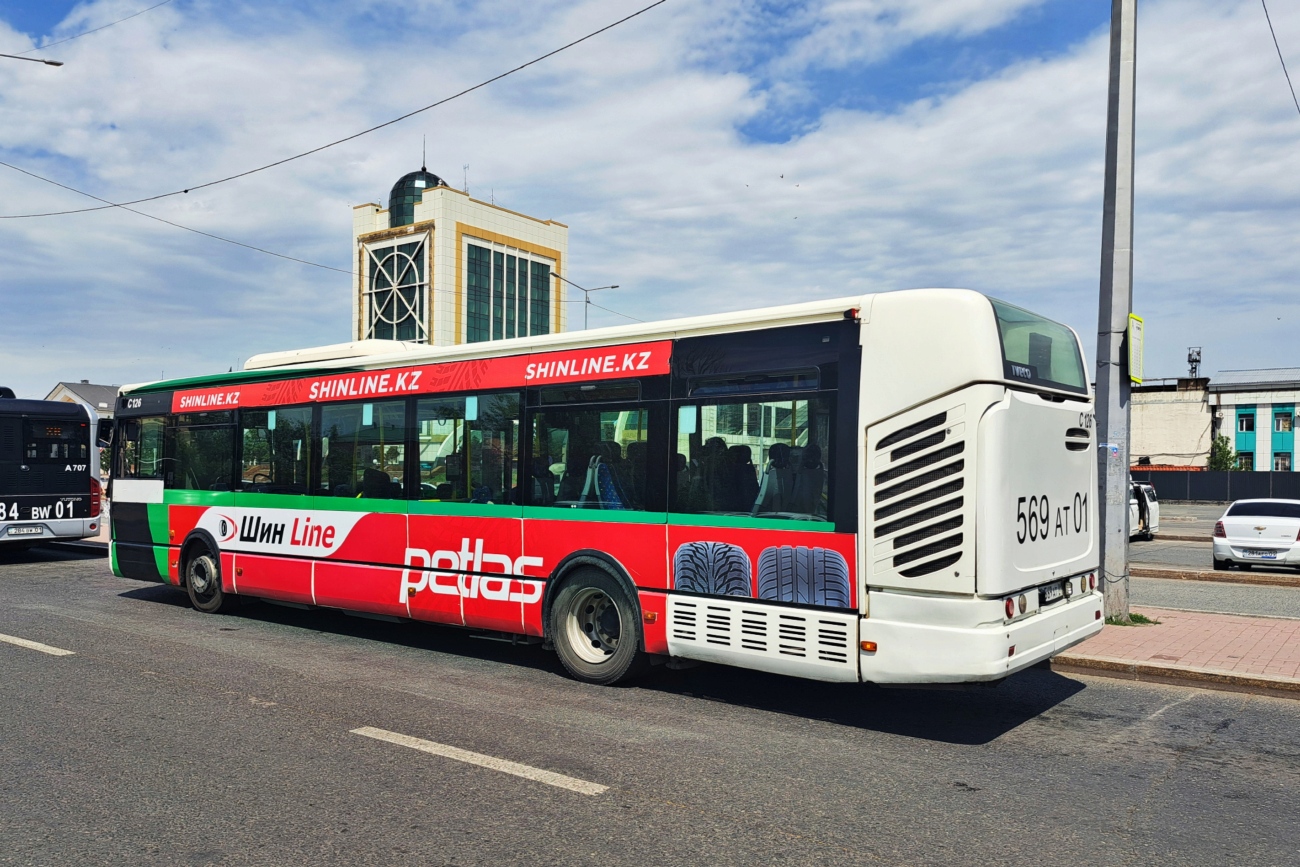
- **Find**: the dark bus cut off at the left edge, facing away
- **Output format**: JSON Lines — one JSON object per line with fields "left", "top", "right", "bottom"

{"left": 0, "top": 389, "right": 101, "bottom": 551}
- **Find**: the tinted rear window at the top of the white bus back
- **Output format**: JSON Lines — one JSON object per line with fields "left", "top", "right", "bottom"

{"left": 989, "top": 299, "right": 1088, "bottom": 394}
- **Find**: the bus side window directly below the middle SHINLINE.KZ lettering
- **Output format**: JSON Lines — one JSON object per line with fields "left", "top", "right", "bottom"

{"left": 319, "top": 400, "right": 406, "bottom": 499}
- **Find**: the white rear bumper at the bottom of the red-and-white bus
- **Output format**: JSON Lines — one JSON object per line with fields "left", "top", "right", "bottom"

{"left": 859, "top": 591, "right": 1105, "bottom": 684}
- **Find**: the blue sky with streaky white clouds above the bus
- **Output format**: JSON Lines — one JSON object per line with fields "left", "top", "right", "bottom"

{"left": 0, "top": 0, "right": 1300, "bottom": 396}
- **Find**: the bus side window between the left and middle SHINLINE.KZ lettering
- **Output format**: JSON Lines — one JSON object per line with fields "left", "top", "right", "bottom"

{"left": 239, "top": 407, "right": 312, "bottom": 494}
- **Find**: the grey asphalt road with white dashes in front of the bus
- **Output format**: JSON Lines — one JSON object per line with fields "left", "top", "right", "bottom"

{"left": 0, "top": 551, "right": 1300, "bottom": 867}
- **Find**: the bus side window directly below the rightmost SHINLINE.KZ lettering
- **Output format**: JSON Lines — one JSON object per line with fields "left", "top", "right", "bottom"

{"left": 528, "top": 407, "right": 650, "bottom": 511}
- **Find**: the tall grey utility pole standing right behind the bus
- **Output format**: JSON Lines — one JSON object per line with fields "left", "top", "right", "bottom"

{"left": 1097, "top": 0, "right": 1138, "bottom": 620}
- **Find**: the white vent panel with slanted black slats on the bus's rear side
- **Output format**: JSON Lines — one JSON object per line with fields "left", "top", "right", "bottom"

{"left": 867, "top": 406, "right": 975, "bottom": 586}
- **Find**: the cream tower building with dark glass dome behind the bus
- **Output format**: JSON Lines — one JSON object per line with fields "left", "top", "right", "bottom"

{"left": 352, "top": 168, "right": 568, "bottom": 346}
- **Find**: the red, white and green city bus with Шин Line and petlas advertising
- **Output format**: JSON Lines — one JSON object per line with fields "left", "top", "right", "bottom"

{"left": 111, "top": 289, "right": 1104, "bottom": 685}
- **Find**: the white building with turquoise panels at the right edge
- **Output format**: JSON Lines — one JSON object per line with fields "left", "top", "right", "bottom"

{"left": 1209, "top": 368, "right": 1300, "bottom": 472}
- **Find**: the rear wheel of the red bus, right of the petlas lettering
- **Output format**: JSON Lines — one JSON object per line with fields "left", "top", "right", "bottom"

{"left": 550, "top": 569, "right": 649, "bottom": 685}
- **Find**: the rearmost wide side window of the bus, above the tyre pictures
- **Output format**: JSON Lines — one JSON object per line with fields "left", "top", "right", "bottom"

{"left": 672, "top": 398, "right": 832, "bottom": 521}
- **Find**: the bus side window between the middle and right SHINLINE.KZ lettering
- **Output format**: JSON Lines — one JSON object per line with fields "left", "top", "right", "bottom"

{"left": 417, "top": 394, "right": 519, "bottom": 504}
